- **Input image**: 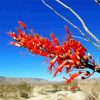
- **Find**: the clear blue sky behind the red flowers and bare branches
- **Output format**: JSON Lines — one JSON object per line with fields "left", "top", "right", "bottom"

{"left": 0, "top": 0, "right": 100, "bottom": 80}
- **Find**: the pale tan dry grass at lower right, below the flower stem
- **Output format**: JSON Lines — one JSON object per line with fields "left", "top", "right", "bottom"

{"left": 78, "top": 79, "right": 100, "bottom": 100}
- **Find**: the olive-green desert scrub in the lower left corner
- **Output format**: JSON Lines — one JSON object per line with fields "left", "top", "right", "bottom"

{"left": 0, "top": 82, "right": 33, "bottom": 100}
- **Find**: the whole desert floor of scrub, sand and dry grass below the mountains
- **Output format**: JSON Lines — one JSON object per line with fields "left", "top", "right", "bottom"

{"left": 0, "top": 79, "right": 100, "bottom": 100}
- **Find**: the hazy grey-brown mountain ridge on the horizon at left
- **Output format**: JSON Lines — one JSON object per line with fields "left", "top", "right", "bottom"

{"left": 0, "top": 76, "right": 49, "bottom": 84}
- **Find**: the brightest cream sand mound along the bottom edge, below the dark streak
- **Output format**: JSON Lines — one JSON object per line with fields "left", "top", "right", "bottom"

{"left": 27, "top": 91, "right": 92, "bottom": 100}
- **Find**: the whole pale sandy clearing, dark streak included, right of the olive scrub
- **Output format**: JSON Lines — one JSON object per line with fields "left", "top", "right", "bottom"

{"left": 24, "top": 85, "right": 100, "bottom": 100}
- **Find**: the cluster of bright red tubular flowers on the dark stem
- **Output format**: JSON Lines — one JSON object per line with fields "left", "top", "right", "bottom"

{"left": 8, "top": 21, "right": 96, "bottom": 84}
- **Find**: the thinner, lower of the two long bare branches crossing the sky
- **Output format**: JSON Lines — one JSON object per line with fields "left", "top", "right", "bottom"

{"left": 42, "top": 0, "right": 100, "bottom": 51}
